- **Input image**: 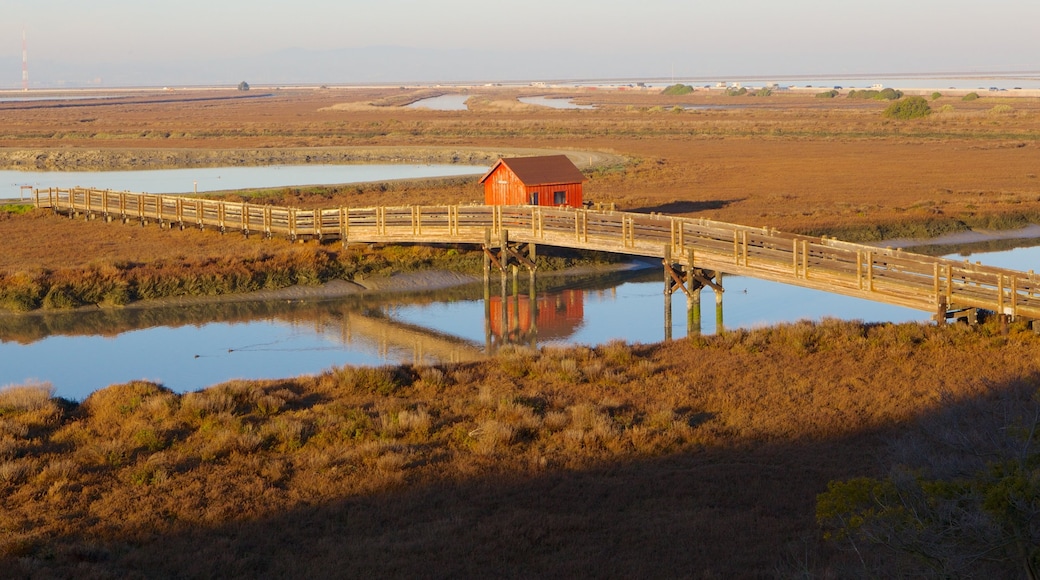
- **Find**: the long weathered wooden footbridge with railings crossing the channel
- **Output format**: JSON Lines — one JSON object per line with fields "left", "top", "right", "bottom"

{"left": 33, "top": 188, "right": 1040, "bottom": 323}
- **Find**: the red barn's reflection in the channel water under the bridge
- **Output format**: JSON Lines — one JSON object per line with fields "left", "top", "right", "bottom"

{"left": 490, "top": 290, "right": 584, "bottom": 342}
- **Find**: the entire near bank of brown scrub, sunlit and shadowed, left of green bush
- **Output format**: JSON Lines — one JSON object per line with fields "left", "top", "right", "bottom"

{"left": 0, "top": 321, "right": 1040, "bottom": 577}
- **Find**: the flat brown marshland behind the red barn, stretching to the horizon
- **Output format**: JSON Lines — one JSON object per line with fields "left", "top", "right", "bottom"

{"left": 0, "top": 88, "right": 1040, "bottom": 241}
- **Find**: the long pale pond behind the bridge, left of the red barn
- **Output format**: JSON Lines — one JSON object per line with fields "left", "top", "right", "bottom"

{"left": 0, "top": 164, "right": 488, "bottom": 199}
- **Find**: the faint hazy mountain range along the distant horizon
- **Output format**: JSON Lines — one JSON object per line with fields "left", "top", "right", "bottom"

{"left": 0, "top": 47, "right": 668, "bottom": 88}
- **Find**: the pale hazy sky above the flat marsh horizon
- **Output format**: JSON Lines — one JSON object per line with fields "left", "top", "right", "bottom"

{"left": 0, "top": 0, "right": 1040, "bottom": 88}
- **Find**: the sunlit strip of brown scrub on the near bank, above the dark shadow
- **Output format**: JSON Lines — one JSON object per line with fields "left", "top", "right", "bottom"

{"left": 0, "top": 320, "right": 1040, "bottom": 574}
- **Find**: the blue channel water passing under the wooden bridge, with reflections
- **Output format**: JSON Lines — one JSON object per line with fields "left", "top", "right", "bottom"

{"left": 0, "top": 246, "right": 1040, "bottom": 399}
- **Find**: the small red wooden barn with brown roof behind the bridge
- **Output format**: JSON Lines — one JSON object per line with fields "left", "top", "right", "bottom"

{"left": 480, "top": 155, "right": 584, "bottom": 208}
